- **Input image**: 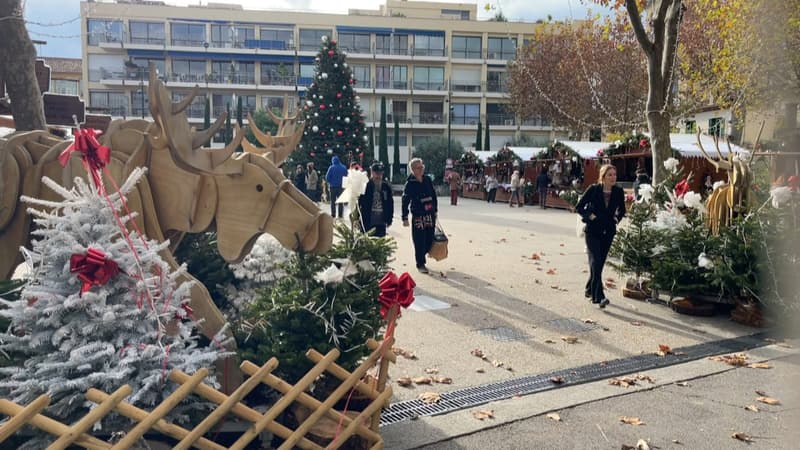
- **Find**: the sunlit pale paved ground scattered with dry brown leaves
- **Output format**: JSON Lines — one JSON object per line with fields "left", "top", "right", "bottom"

{"left": 381, "top": 198, "right": 797, "bottom": 449}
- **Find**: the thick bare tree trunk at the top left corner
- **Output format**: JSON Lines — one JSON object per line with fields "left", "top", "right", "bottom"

{"left": 0, "top": 0, "right": 47, "bottom": 131}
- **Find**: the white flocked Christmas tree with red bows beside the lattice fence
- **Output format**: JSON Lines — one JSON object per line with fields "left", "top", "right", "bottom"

{"left": 0, "top": 169, "right": 224, "bottom": 423}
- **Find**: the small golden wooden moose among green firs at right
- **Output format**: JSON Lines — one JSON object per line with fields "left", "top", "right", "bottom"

{"left": 697, "top": 124, "right": 763, "bottom": 235}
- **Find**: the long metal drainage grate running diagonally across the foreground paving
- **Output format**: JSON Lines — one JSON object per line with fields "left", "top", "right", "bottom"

{"left": 381, "top": 333, "right": 766, "bottom": 426}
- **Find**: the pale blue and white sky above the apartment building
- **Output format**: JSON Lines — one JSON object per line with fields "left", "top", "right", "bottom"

{"left": 22, "top": 0, "right": 598, "bottom": 58}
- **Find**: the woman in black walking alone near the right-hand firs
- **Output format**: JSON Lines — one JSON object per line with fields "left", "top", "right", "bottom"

{"left": 575, "top": 164, "right": 625, "bottom": 308}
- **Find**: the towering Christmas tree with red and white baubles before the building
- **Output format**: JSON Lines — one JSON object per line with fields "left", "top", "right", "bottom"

{"left": 288, "top": 36, "right": 372, "bottom": 174}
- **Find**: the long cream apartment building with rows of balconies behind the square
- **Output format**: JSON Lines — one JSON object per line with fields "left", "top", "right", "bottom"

{"left": 81, "top": 0, "right": 553, "bottom": 161}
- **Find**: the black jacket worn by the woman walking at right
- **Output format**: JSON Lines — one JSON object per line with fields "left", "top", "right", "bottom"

{"left": 575, "top": 184, "right": 625, "bottom": 236}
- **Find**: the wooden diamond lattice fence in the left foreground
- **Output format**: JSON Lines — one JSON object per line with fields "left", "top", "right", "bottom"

{"left": 0, "top": 336, "right": 395, "bottom": 450}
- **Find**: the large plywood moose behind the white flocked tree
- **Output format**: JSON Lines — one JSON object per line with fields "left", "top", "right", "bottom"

{"left": 0, "top": 63, "right": 333, "bottom": 390}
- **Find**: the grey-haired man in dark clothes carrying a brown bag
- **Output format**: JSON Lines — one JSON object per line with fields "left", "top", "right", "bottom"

{"left": 400, "top": 158, "right": 439, "bottom": 273}
